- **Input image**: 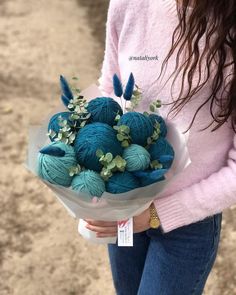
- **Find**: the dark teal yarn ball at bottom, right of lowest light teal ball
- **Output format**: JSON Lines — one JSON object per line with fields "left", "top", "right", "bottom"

{"left": 106, "top": 171, "right": 140, "bottom": 194}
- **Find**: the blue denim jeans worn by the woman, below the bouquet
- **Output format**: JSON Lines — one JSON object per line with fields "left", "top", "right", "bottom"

{"left": 108, "top": 213, "right": 222, "bottom": 295}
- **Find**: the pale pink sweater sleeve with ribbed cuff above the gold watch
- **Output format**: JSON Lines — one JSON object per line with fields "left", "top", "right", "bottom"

{"left": 154, "top": 135, "right": 236, "bottom": 233}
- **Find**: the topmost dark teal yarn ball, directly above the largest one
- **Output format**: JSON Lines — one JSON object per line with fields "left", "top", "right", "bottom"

{"left": 87, "top": 97, "right": 123, "bottom": 126}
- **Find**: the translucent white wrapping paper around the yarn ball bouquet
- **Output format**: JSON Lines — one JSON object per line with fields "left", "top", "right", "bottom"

{"left": 26, "top": 85, "right": 191, "bottom": 243}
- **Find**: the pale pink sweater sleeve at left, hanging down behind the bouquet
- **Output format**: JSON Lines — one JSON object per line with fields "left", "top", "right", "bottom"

{"left": 98, "top": 0, "right": 120, "bottom": 95}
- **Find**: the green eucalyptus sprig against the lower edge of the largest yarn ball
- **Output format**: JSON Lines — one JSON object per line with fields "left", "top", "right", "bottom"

{"left": 96, "top": 150, "right": 126, "bottom": 181}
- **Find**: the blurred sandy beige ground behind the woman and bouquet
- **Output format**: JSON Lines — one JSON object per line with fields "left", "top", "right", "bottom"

{"left": 0, "top": 0, "right": 236, "bottom": 295}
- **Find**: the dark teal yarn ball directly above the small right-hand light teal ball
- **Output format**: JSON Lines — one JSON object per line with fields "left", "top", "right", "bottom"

{"left": 118, "top": 112, "right": 154, "bottom": 146}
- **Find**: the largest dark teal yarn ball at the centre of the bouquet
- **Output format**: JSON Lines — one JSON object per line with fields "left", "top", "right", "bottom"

{"left": 74, "top": 122, "right": 123, "bottom": 171}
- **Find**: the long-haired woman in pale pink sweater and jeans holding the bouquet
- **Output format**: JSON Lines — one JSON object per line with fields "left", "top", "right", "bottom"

{"left": 85, "top": 0, "right": 236, "bottom": 295}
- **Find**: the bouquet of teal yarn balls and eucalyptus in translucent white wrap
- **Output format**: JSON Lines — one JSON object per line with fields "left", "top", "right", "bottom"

{"left": 27, "top": 73, "right": 190, "bottom": 243}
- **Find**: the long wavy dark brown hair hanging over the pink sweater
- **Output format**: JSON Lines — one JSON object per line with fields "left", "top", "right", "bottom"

{"left": 152, "top": 0, "right": 236, "bottom": 132}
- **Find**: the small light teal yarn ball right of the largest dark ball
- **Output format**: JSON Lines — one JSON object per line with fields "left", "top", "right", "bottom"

{"left": 123, "top": 144, "right": 151, "bottom": 172}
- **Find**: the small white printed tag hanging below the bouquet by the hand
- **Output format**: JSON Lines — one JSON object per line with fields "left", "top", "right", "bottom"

{"left": 117, "top": 217, "right": 133, "bottom": 247}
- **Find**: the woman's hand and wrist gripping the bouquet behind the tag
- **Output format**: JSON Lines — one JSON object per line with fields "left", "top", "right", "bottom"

{"left": 85, "top": 208, "right": 150, "bottom": 238}
